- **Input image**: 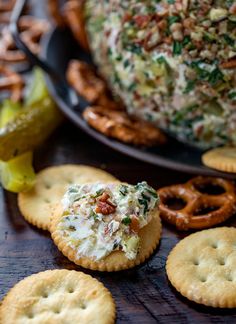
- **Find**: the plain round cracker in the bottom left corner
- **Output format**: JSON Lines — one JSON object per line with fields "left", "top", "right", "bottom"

{"left": 0, "top": 270, "right": 115, "bottom": 324}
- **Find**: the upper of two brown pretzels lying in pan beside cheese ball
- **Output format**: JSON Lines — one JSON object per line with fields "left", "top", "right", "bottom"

{"left": 66, "top": 60, "right": 121, "bottom": 110}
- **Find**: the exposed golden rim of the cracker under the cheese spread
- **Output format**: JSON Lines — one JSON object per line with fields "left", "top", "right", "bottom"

{"left": 50, "top": 205, "right": 161, "bottom": 272}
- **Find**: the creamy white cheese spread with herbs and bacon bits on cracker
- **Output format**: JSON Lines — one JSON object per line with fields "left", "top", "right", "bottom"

{"left": 57, "top": 182, "right": 158, "bottom": 260}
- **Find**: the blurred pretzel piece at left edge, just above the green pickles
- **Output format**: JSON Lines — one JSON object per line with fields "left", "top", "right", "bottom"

{"left": 0, "top": 65, "right": 24, "bottom": 102}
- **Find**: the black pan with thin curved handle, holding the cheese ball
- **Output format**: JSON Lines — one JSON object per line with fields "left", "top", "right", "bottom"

{"left": 10, "top": 0, "right": 236, "bottom": 179}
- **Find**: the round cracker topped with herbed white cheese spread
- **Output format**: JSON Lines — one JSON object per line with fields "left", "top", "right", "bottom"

{"left": 51, "top": 182, "right": 161, "bottom": 271}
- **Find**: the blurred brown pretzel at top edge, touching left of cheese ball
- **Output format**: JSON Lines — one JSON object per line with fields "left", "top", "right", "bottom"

{"left": 63, "top": 0, "right": 89, "bottom": 51}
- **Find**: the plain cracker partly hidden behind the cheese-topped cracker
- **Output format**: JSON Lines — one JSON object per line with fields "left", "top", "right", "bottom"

{"left": 18, "top": 164, "right": 118, "bottom": 230}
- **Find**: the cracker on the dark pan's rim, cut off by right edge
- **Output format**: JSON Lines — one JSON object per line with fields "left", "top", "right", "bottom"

{"left": 202, "top": 147, "right": 236, "bottom": 173}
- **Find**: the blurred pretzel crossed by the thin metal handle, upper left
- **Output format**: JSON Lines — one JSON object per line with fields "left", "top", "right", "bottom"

{"left": 0, "top": 16, "right": 49, "bottom": 63}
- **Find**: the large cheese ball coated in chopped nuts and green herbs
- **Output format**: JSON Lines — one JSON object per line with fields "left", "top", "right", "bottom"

{"left": 85, "top": 0, "right": 236, "bottom": 149}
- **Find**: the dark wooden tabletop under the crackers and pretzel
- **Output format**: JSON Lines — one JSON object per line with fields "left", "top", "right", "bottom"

{"left": 0, "top": 123, "right": 236, "bottom": 324}
